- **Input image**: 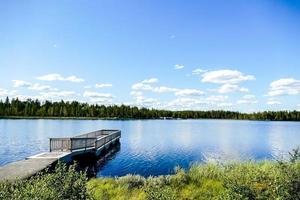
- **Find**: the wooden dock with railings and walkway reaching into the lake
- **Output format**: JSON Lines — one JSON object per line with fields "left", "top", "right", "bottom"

{"left": 0, "top": 130, "right": 121, "bottom": 181}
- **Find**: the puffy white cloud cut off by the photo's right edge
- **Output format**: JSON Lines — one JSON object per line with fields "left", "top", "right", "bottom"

{"left": 267, "top": 78, "right": 300, "bottom": 97}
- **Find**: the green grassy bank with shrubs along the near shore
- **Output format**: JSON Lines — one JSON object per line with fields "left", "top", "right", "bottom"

{"left": 0, "top": 152, "right": 300, "bottom": 200}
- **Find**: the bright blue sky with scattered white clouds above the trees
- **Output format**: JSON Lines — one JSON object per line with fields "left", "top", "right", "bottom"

{"left": 0, "top": 0, "right": 300, "bottom": 112}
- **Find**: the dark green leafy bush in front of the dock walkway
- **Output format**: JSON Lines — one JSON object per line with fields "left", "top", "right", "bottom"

{"left": 0, "top": 163, "right": 87, "bottom": 200}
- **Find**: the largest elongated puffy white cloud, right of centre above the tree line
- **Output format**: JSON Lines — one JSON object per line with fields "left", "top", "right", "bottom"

{"left": 201, "top": 69, "right": 255, "bottom": 84}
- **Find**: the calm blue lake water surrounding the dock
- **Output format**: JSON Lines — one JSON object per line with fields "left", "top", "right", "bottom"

{"left": 0, "top": 120, "right": 300, "bottom": 176}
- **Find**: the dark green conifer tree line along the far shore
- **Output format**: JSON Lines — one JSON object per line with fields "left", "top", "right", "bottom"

{"left": 0, "top": 98, "right": 300, "bottom": 121}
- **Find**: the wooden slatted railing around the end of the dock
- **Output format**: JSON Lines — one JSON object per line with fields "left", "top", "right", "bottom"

{"left": 50, "top": 130, "right": 121, "bottom": 152}
